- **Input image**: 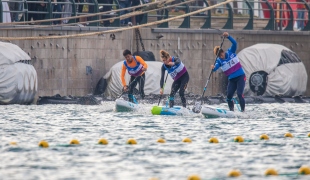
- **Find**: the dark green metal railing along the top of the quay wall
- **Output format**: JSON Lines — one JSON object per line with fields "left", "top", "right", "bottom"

{"left": 0, "top": 0, "right": 310, "bottom": 31}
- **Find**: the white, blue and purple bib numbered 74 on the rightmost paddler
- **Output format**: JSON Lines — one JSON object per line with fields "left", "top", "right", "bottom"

{"left": 221, "top": 53, "right": 242, "bottom": 76}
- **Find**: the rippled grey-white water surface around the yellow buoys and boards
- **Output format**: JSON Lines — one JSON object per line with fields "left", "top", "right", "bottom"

{"left": 0, "top": 102, "right": 310, "bottom": 180}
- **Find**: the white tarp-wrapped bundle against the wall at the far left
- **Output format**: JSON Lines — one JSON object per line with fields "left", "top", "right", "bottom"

{"left": 0, "top": 42, "right": 38, "bottom": 104}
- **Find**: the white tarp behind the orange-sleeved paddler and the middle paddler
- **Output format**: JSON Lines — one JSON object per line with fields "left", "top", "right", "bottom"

{"left": 103, "top": 61, "right": 173, "bottom": 97}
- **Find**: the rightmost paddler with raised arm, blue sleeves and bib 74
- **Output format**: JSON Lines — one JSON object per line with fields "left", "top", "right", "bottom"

{"left": 211, "top": 32, "right": 246, "bottom": 112}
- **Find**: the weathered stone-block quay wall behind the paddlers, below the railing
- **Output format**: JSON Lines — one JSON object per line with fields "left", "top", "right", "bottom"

{"left": 0, "top": 27, "right": 310, "bottom": 96}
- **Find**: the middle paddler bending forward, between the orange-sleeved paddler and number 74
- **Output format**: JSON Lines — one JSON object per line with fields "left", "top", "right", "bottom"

{"left": 160, "top": 50, "right": 189, "bottom": 108}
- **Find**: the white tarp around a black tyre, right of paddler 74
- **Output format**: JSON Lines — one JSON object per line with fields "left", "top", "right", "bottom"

{"left": 238, "top": 44, "right": 308, "bottom": 96}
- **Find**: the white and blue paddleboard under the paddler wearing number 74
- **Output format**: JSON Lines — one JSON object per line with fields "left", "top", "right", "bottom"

{"left": 201, "top": 106, "right": 235, "bottom": 118}
